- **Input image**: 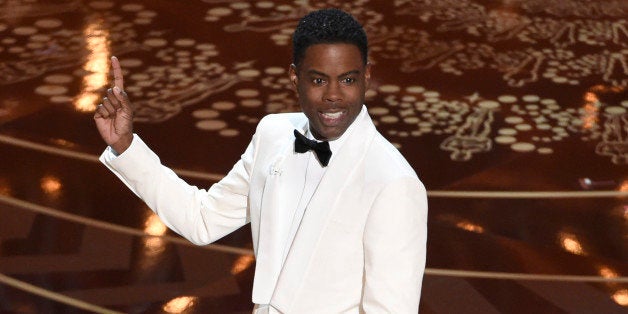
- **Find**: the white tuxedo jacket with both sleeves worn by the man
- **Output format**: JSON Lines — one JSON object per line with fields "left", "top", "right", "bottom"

{"left": 101, "top": 106, "right": 427, "bottom": 314}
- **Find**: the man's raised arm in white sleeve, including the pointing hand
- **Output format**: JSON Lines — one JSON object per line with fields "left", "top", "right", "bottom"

{"left": 94, "top": 57, "right": 255, "bottom": 245}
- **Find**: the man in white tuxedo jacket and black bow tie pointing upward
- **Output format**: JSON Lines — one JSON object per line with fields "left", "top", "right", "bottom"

{"left": 94, "top": 9, "right": 427, "bottom": 313}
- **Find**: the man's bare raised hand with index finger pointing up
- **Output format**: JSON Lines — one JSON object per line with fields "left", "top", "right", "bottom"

{"left": 94, "top": 57, "right": 133, "bottom": 154}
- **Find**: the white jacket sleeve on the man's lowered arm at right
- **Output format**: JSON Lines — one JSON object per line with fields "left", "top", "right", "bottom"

{"left": 362, "top": 177, "right": 427, "bottom": 314}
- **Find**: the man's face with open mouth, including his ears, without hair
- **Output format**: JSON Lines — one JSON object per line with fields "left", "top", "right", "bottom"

{"left": 290, "top": 43, "right": 371, "bottom": 140}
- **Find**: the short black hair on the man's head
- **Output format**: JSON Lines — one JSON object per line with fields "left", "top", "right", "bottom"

{"left": 292, "top": 8, "right": 368, "bottom": 66}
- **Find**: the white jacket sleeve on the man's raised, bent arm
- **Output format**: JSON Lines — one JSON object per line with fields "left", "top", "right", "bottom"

{"left": 100, "top": 135, "right": 256, "bottom": 245}
